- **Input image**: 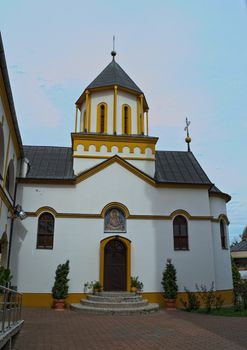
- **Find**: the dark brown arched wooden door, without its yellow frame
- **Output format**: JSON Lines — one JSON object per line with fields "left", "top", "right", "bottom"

{"left": 104, "top": 238, "right": 127, "bottom": 291}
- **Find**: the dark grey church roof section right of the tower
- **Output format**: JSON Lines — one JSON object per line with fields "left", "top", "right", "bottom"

{"left": 154, "top": 151, "right": 212, "bottom": 185}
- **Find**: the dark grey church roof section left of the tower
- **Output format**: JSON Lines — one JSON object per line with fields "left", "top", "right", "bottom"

{"left": 23, "top": 146, "right": 74, "bottom": 179}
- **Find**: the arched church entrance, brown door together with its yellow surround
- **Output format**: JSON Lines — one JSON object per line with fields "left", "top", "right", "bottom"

{"left": 100, "top": 236, "right": 131, "bottom": 291}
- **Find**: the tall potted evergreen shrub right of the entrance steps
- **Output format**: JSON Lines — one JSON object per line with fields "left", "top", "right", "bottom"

{"left": 161, "top": 259, "right": 178, "bottom": 309}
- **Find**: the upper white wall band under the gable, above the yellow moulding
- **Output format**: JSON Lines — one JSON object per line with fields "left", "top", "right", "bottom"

{"left": 18, "top": 163, "right": 210, "bottom": 216}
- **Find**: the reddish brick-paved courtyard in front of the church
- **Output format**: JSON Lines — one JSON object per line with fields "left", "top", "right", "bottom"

{"left": 10, "top": 309, "right": 247, "bottom": 350}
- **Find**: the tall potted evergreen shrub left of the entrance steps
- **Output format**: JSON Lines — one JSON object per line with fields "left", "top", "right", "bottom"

{"left": 52, "top": 260, "right": 69, "bottom": 310}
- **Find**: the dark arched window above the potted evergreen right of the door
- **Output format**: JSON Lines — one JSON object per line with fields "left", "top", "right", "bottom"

{"left": 173, "top": 215, "right": 189, "bottom": 250}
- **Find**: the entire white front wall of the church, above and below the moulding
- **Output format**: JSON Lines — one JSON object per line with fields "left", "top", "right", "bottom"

{"left": 12, "top": 163, "right": 232, "bottom": 293}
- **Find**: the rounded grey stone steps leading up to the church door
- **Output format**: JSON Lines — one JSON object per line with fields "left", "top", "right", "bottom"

{"left": 70, "top": 292, "right": 159, "bottom": 315}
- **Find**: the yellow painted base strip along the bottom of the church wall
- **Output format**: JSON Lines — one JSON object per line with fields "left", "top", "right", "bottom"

{"left": 23, "top": 289, "right": 233, "bottom": 308}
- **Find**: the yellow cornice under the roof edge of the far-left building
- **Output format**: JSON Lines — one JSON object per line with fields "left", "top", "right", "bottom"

{"left": 0, "top": 69, "right": 21, "bottom": 159}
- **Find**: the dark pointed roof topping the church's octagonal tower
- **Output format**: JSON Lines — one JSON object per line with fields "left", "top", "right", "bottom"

{"left": 86, "top": 59, "right": 142, "bottom": 94}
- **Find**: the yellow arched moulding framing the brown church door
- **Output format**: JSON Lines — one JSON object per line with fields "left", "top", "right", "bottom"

{"left": 100, "top": 235, "right": 131, "bottom": 291}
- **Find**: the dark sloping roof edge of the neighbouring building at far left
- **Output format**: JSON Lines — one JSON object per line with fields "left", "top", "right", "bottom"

{"left": 0, "top": 32, "right": 23, "bottom": 155}
